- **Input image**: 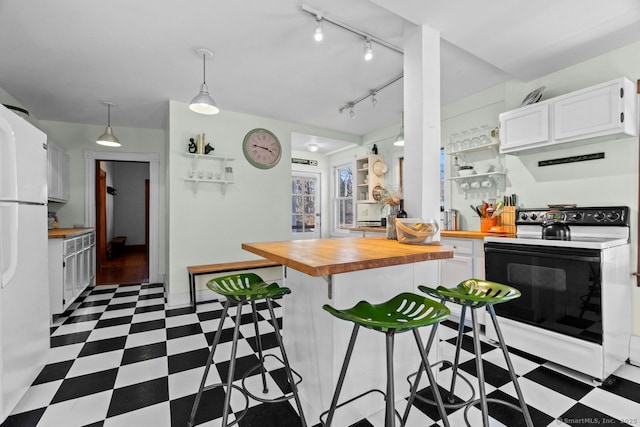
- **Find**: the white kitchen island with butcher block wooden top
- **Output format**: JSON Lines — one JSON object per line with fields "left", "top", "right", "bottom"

{"left": 242, "top": 237, "right": 453, "bottom": 426}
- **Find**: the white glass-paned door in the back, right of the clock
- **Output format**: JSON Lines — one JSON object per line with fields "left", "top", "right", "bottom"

{"left": 291, "top": 171, "right": 322, "bottom": 240}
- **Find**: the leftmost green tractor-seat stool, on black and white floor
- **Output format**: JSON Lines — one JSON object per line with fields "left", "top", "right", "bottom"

{"left": 187, "top": 273, "right": 307, "bottom": 427}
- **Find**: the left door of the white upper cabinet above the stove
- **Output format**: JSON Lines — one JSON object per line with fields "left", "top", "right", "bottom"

{"left": 500, "top": 103, "right": 550, "bottom": 153}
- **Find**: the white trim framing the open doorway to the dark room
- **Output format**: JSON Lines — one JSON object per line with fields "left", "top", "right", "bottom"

{"left": 84, "top": 150, "right": 160, "bottom": 283}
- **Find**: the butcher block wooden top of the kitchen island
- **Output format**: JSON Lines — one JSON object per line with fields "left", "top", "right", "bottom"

{"left": 242, "top": 236, "right": 453, "bottom": 277}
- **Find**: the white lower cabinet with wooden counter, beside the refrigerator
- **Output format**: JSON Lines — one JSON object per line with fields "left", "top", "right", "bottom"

{"left": 49, "top": 230, "right": 96, "bottom": 315}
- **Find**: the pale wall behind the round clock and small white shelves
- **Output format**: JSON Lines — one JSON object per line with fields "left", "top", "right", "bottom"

{"left": 167, "top": 101, "right": 359, "bottom": 305}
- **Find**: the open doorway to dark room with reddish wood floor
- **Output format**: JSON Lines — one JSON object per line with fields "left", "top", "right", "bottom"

{"left": 95, "top": 160, "right": 149, "bottom": 285}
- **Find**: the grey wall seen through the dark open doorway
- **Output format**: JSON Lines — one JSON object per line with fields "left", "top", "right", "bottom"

{"left": 110, "top": 162, "right": 149, "bottom": 246}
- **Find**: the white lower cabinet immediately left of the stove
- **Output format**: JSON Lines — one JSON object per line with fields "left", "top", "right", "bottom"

{"left": 440, "top": 237, "right": 485, "bottom": 324}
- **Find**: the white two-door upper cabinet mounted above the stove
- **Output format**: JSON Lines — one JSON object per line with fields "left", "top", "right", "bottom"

{"left": 500, "top": 78, "right": 638, "bottom": 153}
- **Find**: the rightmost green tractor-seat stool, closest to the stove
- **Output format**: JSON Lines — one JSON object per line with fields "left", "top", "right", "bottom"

{"left": 403, "top": 279, "right": 534, "bottom": 427}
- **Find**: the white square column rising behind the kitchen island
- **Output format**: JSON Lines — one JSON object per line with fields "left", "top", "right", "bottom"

{"left": 403, "top": 26, "right": 440, "bottom": 220}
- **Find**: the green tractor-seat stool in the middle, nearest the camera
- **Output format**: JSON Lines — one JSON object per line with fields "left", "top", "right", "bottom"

{"left": 320, "top": 293, "right": 451, "bottom": 427}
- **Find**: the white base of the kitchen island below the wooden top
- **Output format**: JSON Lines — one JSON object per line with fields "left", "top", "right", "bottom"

{"left": 284, "top": 261, "right": 440, "bottom": 427}
